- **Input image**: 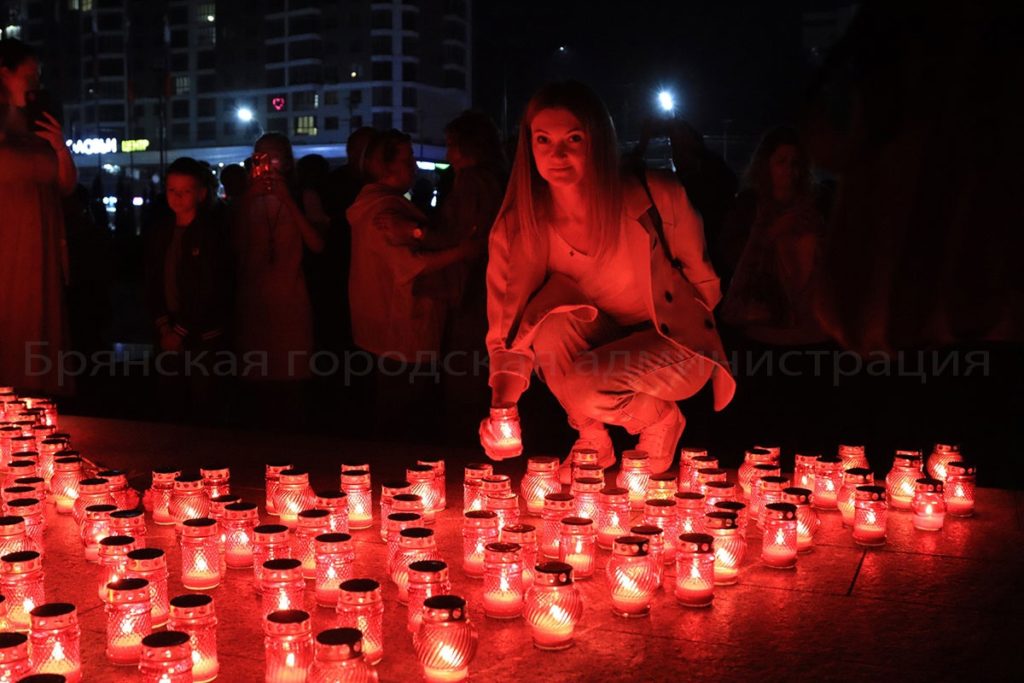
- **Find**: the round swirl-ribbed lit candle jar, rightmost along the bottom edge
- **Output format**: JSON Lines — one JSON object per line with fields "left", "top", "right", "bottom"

{"left": 413, "top": 595, "right": 477, "bottom": 683}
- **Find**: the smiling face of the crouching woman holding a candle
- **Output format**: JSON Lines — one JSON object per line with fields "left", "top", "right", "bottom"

{"left": 529, "top": 109, "right": 590, "bottom": 191}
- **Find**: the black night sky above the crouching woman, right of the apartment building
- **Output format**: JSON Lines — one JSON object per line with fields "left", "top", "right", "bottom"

{"left": 473, "top": 0, "right": 851, "bottom": 137}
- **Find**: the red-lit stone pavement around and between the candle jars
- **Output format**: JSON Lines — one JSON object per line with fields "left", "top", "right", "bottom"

{"left": 32, "top": 417, "right": 1024, "bottom": 683}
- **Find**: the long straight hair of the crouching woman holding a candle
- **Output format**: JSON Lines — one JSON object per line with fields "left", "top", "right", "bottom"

{"left": 498, "top": 81, "right": 622, "bottom": 259}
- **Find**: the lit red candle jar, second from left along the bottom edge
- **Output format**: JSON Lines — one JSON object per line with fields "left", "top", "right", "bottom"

{"left": 28, "top": 602, "right": 82, "bottom": 683}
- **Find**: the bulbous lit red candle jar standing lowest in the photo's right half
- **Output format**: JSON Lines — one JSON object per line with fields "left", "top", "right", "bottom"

{"left": 522, "top": 562, "right": 583, "bottom": 650}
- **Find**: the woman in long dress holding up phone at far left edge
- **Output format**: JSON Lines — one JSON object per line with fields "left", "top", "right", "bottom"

{"left": 0, "top": 39, "right": 78, "bottom": 394}
